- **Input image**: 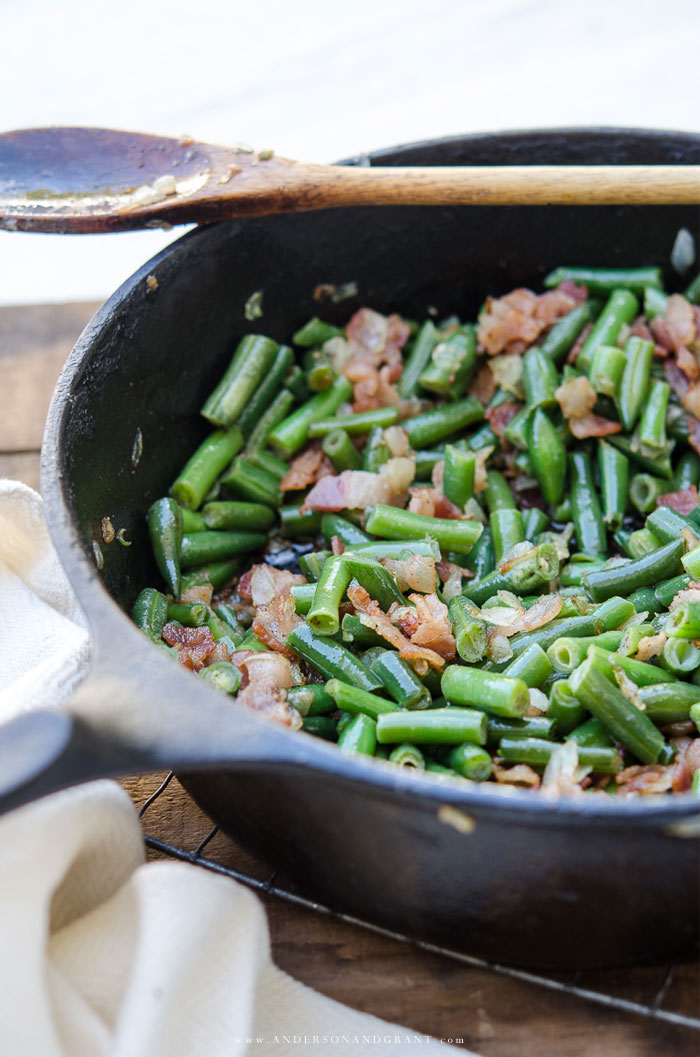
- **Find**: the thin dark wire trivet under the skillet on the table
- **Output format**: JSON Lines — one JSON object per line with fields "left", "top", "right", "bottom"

{"left": 139, "top": 772, "right": 700, "bottom": 1032}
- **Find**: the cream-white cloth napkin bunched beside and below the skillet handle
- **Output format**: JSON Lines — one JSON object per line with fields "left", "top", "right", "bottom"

{"left": 0, "top": 481, "right": 473, "bottom": 1057}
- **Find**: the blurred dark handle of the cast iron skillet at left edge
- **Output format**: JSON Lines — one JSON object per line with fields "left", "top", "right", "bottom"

{"left": 0, "top": 710, "right": 149, "bottom": 815}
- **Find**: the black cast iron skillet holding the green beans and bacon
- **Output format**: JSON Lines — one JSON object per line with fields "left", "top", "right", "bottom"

{"left": 0, "top": 130, "right": 700, "bottom": 966}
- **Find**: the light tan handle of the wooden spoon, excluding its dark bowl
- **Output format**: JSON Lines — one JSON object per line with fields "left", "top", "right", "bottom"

{"left": 293, "top": 165, "right": 700, "bottom": 208}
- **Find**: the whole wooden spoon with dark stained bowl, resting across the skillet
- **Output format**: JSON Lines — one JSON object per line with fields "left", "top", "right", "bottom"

{"left": 0, "top": 128, "right": 700, "bottom": 234}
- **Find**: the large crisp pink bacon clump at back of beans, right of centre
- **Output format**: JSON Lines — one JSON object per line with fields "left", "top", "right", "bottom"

{"left": 478, "top": 284, "right": 585, "bottom": 356}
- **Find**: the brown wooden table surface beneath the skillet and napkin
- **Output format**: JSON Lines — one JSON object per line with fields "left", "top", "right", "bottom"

{"left": 0, "top": 303, "right": 700, "bottom": 1057}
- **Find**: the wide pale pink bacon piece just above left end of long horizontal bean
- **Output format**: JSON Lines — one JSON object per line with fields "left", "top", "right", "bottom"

{"left": 301, "top": 458, "right": 416, "bottom": 514}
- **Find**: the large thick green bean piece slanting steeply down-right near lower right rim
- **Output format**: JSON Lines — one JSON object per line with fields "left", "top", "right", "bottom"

{"left": 569, "top": 656, "right": 666, "bottom": 763}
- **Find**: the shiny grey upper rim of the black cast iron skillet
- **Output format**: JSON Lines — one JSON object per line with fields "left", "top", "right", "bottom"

{"left": 40, "top": 126, "right": 700, "bottom": 836}
